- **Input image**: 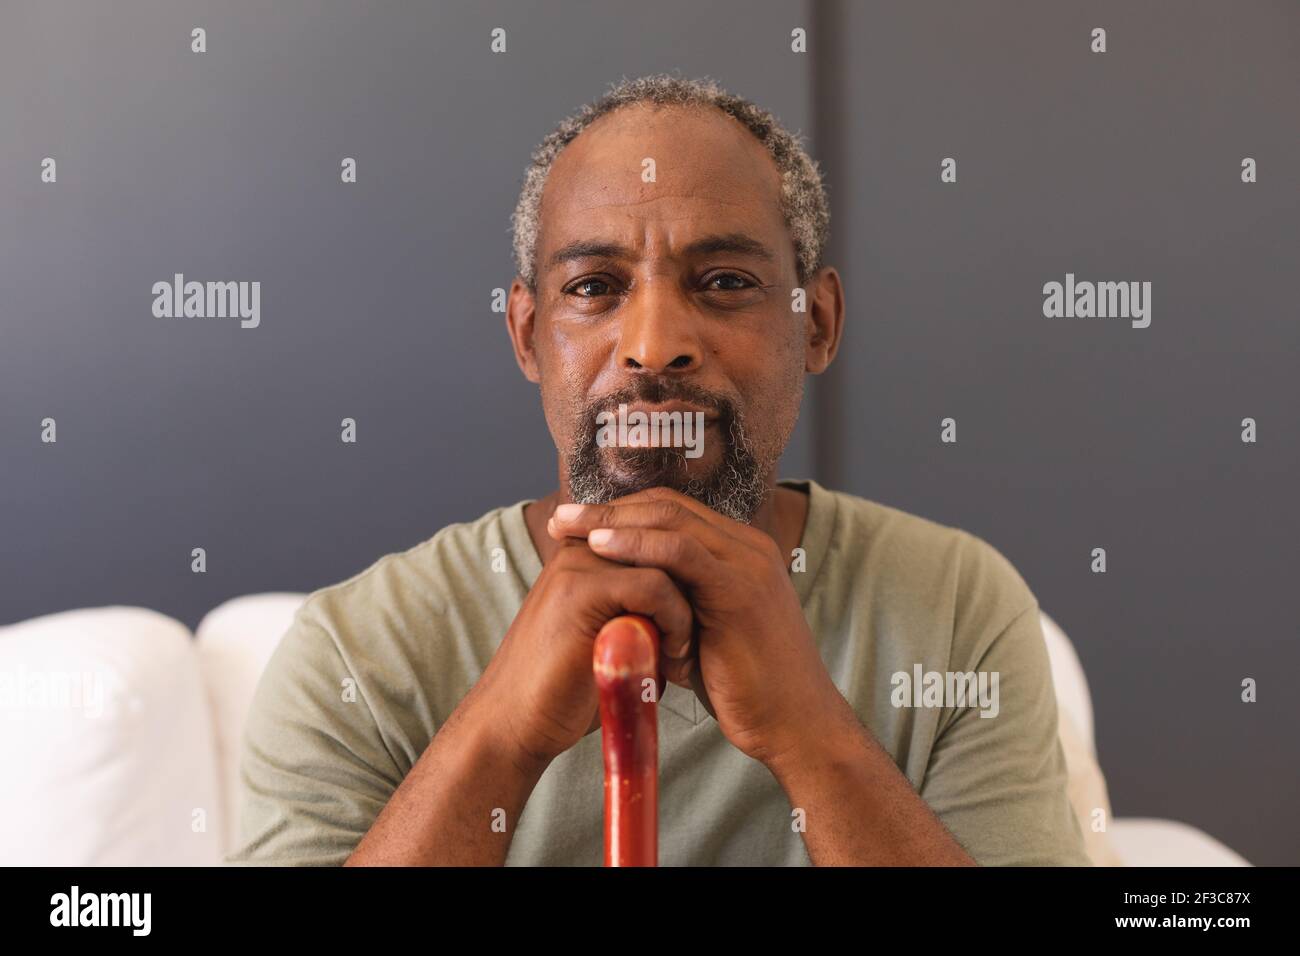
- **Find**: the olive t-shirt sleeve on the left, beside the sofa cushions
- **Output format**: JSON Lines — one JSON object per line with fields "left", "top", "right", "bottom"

{"left": 226, "top": 607, "right": 402, "bottom": 866}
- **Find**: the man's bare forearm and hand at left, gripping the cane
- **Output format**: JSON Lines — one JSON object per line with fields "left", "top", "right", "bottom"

{"left": 347, "top": 530, "right": 692, "bottom": 866}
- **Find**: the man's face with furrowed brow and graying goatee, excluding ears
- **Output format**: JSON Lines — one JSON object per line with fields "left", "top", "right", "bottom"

{"left": 520, "top": 105, "right": 809, "bottom": 522}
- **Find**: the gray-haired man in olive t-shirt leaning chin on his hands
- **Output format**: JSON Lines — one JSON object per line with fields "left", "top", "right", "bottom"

{"left": 230, "top": 75, "right": 1088, "bottom": 865}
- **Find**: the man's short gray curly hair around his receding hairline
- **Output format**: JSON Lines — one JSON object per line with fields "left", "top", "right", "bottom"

{"left": 511, "top": 73, "right": 831, "bottom": 293}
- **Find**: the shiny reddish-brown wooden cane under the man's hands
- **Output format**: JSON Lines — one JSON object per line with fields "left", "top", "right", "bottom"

{"left": 592, "top": 614, "right": 659, "bottom": 866}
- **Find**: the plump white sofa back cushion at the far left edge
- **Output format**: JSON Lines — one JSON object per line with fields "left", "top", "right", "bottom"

{"left": 0, "top": 607, "right": 222, "bottom": 866}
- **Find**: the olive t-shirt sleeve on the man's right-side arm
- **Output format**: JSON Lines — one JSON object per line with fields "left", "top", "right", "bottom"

{"left": 920, "top": 555, "right": 1091, "bottom": 866}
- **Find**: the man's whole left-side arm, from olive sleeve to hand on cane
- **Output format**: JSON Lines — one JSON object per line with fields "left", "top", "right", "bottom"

{"left": 229, "top": 542, "right": 692, "bottom": 865}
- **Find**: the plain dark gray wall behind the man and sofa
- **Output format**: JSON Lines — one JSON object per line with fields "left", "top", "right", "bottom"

{"left": 0, "top": 0, "right": 1300, "bottom": 864}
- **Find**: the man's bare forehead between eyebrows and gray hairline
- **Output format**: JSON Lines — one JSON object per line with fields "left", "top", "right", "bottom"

{"left": 540, "top": 105, "right": 784, "bottom": 257}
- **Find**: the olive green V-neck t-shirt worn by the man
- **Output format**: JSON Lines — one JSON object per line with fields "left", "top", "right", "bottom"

{"left": 228, "top": 481, "right": 1088, "bottom": 866}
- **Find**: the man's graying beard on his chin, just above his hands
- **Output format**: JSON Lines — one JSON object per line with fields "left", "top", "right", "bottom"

{"left": 567, "top": 414, "right": 771, "bottom": 524}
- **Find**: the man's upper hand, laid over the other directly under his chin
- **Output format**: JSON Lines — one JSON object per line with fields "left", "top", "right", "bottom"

{"left": 547, "top": 488, "right": 852, "bottom": 765}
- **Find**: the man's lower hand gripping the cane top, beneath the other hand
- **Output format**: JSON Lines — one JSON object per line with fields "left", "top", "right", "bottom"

{"left": 472, "top": 540, "right": 692, "bottom": 767}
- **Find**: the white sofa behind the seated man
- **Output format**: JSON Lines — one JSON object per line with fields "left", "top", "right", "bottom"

{"left": 0, "top": 593, "right": 1248, "bottom": 866}
